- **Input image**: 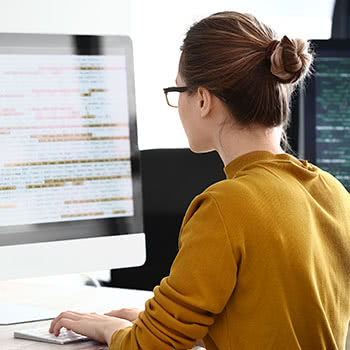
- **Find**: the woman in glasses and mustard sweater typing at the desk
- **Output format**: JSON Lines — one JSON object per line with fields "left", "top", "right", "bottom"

{"left": 50, "top": 12, "right": 350, "bottom": 350}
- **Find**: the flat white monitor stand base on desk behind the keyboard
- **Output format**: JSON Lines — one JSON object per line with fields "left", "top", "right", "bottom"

{"left": 0, "top": 303, "right": 58, "bottom": 326}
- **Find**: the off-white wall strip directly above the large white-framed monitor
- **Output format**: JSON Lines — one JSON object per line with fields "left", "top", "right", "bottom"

{"left": 0, "top": 0, "right": 130, "bottom": 34}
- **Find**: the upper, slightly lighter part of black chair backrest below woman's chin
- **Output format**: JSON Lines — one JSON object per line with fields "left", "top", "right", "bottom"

{"left": 141, "top": 148, "right": 225, "bottom": 216}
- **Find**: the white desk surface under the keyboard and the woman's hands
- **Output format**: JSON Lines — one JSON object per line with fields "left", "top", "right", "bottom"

{"left": 0, "top": 281, "right": 153, "bottom": 350}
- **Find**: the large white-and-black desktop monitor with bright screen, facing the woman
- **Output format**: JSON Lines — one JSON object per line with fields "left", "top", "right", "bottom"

{"left": 0, "top": 34, "right": 146, "bottom": 324}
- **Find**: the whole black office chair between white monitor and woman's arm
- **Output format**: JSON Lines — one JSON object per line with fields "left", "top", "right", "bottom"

{"left": 106, "top": 148, "right": 225, "bottom": 290}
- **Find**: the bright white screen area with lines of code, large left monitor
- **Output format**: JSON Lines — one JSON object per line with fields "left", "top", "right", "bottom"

{"left": 0, "top": 54, "right": 134, "bottom": 226}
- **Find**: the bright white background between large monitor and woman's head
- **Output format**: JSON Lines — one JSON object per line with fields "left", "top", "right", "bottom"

{"left": 131, "top": 0, "right": 334, "bottom": 149}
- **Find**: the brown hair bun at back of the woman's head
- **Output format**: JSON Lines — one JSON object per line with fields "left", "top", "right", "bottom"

{"left": 267, "top": 36, "right": 313, "bottom": 84}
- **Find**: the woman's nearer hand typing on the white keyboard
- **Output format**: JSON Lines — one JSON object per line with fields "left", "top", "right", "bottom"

{"left": 49, "top": 311, "right": 132, "bottom": 345}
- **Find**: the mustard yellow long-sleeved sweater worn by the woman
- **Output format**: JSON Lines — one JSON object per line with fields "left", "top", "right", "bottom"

{"left": 110, "top": 151, "right": 350, "bottom": 350}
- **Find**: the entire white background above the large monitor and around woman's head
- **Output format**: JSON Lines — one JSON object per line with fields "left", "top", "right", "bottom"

{"left": 0, "top": 0, "right": 335, "bottom": 149}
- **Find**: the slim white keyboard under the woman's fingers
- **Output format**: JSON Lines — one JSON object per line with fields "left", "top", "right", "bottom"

{"left": 13, "top": 325, "right": 89, "bottom": 345}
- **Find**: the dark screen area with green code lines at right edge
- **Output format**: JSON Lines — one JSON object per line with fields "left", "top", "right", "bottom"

{"left": 315, "top": 57, "right": 350, "bottom": 190}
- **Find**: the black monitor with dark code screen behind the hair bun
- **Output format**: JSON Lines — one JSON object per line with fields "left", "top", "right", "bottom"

{"left": 299, "top": 39, "right": 350, "bottom": 191}
